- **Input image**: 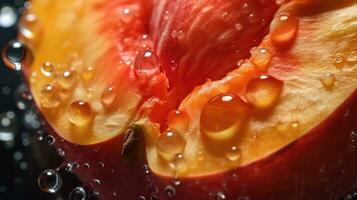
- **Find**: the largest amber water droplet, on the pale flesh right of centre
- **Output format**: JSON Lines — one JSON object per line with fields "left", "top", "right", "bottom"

{"left": 200, "top": 94, "right": 249, "bottom": 140}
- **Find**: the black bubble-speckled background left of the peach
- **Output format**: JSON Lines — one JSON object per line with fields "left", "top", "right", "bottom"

{"left": 0, "top": 0, "right": 80, "bottom": 200}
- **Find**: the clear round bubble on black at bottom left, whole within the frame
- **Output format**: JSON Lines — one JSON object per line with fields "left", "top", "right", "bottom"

{"left": 37, "top": 169, "right": 62, "bottom": 193}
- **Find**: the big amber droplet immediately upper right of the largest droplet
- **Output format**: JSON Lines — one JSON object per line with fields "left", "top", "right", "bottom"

{"left": 246, "top": 75, "right": 283, "bottom": 109}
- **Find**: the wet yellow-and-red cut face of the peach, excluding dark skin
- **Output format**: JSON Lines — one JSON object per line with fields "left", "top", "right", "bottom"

{"left": 21, "top": 0, "right": 357, "bottom": 182}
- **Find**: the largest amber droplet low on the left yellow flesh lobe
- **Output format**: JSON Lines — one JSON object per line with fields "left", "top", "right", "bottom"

{"left": 68, "top": 101, "right": 94, "bottom": 127}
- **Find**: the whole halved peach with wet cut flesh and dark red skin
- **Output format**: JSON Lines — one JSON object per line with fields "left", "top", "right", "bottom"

{"left": 11, "top": 0, "right": 357, "bottom": 200}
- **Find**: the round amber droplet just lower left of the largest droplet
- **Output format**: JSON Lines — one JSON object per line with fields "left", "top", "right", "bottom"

{"left": 156, "top": 130, "right": 186, "bottom": 160}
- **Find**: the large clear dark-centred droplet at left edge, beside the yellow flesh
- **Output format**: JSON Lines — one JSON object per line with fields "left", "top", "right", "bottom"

{"left": 2, "top": 40, "right": 33, "bottom": 71}
